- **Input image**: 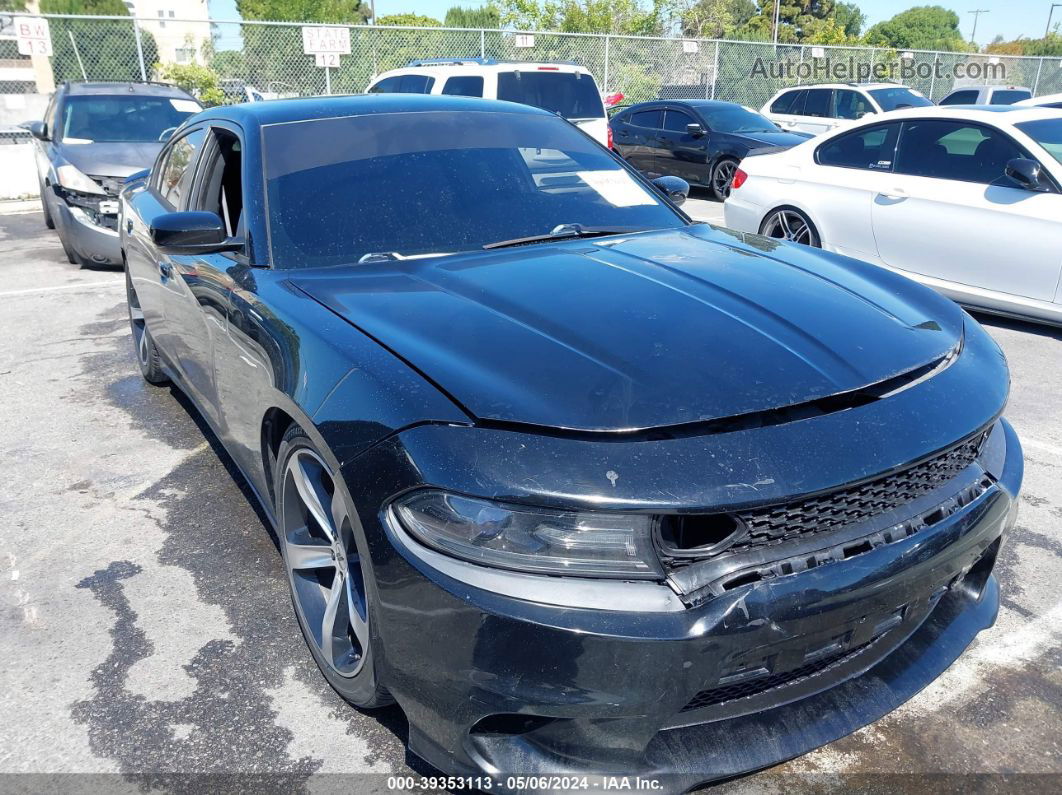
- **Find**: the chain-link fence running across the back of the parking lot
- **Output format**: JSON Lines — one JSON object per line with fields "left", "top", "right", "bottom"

{"left": 6, "top": 15, "right": 1062, "bottom": 108}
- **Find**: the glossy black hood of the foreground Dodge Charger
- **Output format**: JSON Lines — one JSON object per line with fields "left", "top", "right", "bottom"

{"left": 292, "top": 226, "right": 962, "bottom": 431}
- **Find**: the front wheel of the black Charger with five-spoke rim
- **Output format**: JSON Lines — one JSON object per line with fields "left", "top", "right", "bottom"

{"left": 275, "top": 426, "right": 393, "bottom": 708}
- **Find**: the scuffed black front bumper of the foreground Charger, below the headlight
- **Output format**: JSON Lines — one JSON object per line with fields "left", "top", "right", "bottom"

{"left": 363, "top": 421, "right": 1022, "bottom": 791}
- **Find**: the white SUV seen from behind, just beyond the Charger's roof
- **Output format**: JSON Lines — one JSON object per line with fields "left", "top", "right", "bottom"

{"left": 365, "top": 58, "right": 609, "bottom": 146}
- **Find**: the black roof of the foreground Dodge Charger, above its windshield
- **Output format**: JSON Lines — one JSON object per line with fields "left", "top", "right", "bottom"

{"left": 191, "top": 93, "right": 554, "bottom": 129}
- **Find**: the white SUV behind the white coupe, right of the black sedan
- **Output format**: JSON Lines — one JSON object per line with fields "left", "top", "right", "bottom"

{"left": 759, "top": 83, "right": 932, "bottom": 135}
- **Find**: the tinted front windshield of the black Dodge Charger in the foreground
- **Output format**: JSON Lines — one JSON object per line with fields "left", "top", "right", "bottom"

{"left": 262, "top": 110, "right": 686, "bottom": 267}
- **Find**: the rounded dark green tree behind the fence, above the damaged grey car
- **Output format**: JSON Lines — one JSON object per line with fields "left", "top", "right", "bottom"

{"left": 40, "top": 0, "right": 158, "bottom": 83}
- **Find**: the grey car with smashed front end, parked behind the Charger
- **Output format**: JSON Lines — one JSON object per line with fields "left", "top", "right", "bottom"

{"left": 30, "top": 82, "right": 202, "bottom": 265}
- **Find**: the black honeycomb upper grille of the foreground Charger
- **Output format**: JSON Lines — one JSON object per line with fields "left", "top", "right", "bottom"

{"left": 727, "top": 433, "right": 987, "bottom": 552}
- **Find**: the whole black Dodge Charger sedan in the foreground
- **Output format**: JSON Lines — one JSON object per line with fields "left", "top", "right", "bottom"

{"left": 121, "top": 94, "right": 1023, "bottom": 790}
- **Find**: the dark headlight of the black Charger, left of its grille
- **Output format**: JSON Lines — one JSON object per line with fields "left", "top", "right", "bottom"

{"left": 394, "top": 490, "right": 663, "bottom": 580}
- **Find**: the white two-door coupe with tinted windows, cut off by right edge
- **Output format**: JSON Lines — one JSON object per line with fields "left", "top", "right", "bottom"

{"left": 723, "top": 105, "right": 1062, "bottom": 323}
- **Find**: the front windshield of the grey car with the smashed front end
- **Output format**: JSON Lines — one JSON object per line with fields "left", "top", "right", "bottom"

{"left": 61, "top": 94, "right": 202, "bottom": 143}
